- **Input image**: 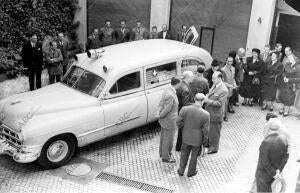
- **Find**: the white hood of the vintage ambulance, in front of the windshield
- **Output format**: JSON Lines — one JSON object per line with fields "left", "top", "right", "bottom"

{"left": 0, "top": 83, "right": 100, "bottom": 132}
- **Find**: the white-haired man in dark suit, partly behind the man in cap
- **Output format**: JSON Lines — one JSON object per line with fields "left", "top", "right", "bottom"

{"left": 175, "top": 71, "right": 194, "bottom": 151}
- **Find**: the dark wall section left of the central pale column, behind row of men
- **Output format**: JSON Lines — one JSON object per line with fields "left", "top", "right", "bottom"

{"left": 87, "top": 0, "right": 151, "bottom": 33}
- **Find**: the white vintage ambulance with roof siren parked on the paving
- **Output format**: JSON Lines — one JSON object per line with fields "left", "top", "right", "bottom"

{"left": 0, "top": 37, "right": 212, "bottom": 168}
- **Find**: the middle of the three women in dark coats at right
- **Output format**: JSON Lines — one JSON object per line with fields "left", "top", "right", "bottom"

{"left": 262, "top": 52, "right": 283, "bottom": 111}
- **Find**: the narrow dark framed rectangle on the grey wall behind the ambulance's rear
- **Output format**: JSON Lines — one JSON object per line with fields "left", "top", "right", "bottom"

{"left": 199, "top": 27, "right": 215, "bottom": 55}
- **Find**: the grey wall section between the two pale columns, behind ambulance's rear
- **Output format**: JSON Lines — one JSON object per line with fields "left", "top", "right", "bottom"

{"left": 170, "top": 0, "right": 252, "bottom": 60}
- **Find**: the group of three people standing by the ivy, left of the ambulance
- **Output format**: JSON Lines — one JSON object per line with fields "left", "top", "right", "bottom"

{"left": 22, "top": 33, "right": 69, "bottom": 90}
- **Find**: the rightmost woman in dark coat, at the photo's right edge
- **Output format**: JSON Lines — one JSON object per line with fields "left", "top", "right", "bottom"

{"left": 279, "top": 47, "right": 300, "bottom": 116}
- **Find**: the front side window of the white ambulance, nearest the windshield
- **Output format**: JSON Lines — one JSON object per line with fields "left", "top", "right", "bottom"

{"left": 109, "top": 72, "right": 141, "bottom": 94}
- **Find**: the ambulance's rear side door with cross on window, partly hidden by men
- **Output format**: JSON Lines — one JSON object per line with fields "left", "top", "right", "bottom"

{"left": 144, "top": 60, "right": 178, "bottom": 122}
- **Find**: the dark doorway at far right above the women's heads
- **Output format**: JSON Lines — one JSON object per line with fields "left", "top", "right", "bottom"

{"left": 276, "top": 13, "right": 300, "bottom": 52}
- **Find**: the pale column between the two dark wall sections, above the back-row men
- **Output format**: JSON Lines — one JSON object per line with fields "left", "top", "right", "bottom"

{"left": 149, "top": 0, "right": 171, "bottom": 31}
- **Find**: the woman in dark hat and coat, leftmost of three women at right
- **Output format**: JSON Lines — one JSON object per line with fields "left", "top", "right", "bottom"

{"left": 239, "top": 48, "right": 265, "bottom": 106}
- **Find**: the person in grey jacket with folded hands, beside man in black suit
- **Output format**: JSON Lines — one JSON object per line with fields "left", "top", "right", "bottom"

{"left": 46, "top": 41, "right": 63, "bottom": 84}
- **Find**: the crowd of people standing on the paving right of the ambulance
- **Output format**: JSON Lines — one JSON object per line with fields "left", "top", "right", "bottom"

{"left": 156, "top": 43, "right": 300, "bottom": 192}
